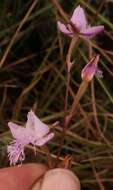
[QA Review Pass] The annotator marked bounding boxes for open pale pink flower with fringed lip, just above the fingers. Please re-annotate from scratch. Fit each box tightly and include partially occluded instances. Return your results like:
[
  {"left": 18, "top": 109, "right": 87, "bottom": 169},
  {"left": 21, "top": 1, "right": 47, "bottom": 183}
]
[{"left": 7, "top": 110, "right": 54, "bottom": 165}]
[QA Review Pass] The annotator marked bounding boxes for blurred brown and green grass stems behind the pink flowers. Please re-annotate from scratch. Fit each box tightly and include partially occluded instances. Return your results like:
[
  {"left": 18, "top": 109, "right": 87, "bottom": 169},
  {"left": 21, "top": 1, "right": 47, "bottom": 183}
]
[{"left": 0, "top": 0, "right": 113, "bottom": 190}]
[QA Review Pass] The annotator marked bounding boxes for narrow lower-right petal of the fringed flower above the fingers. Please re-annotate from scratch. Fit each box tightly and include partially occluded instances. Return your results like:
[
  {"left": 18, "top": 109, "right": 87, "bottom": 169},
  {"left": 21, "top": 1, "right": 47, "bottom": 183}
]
[{"left": 34, "top": 133, "right": 54, "bottom": 146}]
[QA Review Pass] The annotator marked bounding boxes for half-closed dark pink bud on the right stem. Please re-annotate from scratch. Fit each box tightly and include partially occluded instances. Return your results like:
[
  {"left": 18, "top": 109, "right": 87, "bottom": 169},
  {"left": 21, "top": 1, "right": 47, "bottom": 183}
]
[{"left": 81, "top": 55, "right": 102, "bottom": 82}]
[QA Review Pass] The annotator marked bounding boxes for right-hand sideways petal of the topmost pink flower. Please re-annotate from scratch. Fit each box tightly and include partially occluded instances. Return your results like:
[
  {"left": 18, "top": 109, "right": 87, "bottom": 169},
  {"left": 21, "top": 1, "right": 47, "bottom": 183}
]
[{"left": 81, "top": 25, "right": 104, "bottom": 38}]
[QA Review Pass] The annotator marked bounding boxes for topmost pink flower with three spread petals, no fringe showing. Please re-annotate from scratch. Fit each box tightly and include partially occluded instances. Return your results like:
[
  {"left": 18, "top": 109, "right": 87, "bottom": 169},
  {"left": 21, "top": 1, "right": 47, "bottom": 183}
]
[{"left": 57, "top": 5, "right": 104, "bottom": 38}]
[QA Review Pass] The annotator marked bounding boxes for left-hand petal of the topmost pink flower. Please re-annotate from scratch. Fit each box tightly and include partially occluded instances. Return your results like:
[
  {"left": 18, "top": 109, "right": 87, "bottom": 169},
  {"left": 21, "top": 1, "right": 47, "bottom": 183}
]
[{"left": 57, "top": 21, "right": 73, "bottom": 37}]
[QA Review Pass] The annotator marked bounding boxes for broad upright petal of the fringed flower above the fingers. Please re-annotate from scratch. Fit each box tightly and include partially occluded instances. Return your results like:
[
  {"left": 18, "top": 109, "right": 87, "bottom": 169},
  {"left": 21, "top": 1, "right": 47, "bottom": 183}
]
[{"left": 26, "top": 110, "right": 49, "bottom": 138}]
